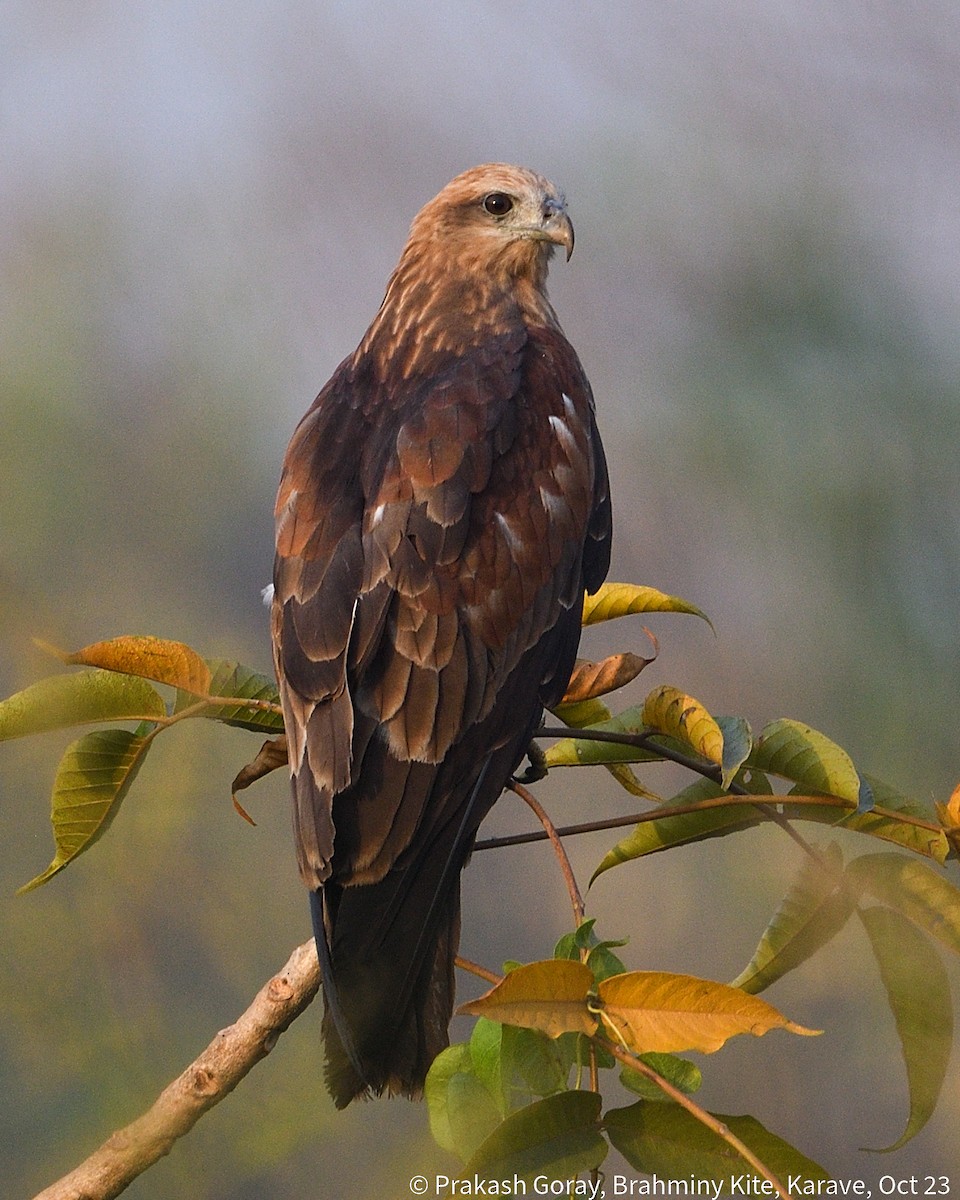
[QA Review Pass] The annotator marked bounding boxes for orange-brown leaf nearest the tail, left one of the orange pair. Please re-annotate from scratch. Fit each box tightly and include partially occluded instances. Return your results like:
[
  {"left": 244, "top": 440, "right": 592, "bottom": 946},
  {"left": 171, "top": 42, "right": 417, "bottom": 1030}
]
[{"left": 457, "top": 959, "right": 596, "bottom": 1038}]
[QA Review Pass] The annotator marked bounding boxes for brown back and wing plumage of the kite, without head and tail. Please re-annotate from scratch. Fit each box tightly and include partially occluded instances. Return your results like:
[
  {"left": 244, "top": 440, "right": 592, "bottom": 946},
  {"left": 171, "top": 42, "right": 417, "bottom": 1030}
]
[{"left": 275, "top": 319, "right": 608, "bottom": 886}]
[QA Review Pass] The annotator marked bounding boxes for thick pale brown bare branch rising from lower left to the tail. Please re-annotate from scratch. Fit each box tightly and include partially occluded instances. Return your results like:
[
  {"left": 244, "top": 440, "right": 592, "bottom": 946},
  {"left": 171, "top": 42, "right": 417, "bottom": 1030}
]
[{"left": 35, "top": 938, "right": 320, "bottom": 1200}]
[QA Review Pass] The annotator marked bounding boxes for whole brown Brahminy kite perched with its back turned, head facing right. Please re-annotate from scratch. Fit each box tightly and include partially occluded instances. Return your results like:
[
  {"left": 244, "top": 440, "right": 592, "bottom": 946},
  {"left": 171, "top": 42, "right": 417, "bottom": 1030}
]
[{"left": 271, "top": 163, "right": 610, "bottom": 1108}]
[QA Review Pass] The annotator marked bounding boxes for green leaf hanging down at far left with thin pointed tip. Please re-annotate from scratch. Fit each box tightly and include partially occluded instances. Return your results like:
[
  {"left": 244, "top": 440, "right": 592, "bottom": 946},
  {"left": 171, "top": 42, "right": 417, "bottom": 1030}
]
[{"left": 19, "top": 730, "right": 150, "bottom": 893}]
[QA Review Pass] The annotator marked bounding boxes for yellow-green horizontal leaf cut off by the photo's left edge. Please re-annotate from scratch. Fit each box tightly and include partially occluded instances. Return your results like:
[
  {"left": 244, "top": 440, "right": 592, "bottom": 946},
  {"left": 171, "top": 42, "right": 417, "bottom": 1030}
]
[{"left": 0, "top": 671, "right": 167, "bottom": 742}]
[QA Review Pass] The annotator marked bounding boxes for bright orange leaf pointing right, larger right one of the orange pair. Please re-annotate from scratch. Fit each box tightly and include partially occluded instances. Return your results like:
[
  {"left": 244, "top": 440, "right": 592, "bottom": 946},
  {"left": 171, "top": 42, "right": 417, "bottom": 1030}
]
[{"left": 598, "top": 971, "right": 817, "bottom": 1054}]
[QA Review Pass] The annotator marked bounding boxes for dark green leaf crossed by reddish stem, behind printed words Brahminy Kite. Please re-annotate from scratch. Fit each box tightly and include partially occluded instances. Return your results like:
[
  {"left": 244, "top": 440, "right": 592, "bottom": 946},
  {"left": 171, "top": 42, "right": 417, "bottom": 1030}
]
[{"left": 604, "top": 1100, "right": 829, "bottom": 1195}]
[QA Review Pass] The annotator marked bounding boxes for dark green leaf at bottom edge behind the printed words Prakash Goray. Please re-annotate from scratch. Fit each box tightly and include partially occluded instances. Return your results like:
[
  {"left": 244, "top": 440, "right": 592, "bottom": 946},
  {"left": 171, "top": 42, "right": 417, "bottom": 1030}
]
[{"left": 450, "top": 1092, "right": 607, "bottom": 1194}]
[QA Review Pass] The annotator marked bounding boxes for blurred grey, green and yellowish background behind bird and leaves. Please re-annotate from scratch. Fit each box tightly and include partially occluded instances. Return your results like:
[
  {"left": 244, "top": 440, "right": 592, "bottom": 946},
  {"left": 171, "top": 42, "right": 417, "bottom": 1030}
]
[{"left": 0, "top": 0, "right": 960, "bottom": 1200}]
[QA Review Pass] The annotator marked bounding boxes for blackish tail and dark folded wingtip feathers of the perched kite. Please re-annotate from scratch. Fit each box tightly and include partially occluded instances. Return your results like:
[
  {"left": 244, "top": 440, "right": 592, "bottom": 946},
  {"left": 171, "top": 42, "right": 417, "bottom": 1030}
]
[{"left": 313, "top": 700, "right": 540, "bottom": 1108}]
